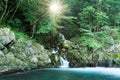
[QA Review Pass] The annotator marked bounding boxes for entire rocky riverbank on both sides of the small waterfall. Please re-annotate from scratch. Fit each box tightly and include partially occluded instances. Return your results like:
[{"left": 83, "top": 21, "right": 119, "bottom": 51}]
[{"left": 0, "top": 28, "right": 120, "bottom": 74}]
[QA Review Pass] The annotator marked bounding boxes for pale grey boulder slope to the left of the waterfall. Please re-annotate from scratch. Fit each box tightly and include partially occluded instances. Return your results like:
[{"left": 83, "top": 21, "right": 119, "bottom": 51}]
[{"left": 0, "top": 28, "right": 51, "bottom": 71}]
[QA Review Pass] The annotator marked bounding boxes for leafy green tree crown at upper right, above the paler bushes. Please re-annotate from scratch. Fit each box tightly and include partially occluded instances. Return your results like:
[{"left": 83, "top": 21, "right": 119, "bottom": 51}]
[{"left": 78, "top": 6, "right": 109, "bottom": 30}]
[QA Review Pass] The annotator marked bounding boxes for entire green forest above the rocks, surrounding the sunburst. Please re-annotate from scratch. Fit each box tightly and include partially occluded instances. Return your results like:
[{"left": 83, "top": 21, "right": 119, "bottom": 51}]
[{"left": 0, "top": 0, "right": 120, "bottom": 67}]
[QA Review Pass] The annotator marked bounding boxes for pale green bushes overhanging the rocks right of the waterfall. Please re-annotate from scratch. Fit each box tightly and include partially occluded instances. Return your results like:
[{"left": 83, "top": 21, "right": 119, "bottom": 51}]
[{"left": 72, "top": 26, "right": 120, "bottom": 50}]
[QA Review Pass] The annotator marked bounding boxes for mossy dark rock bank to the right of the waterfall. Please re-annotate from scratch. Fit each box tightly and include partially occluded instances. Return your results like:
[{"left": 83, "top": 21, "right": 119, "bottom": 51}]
[{"left": 67, "top": 38, "right": 120, "bottom": 67}]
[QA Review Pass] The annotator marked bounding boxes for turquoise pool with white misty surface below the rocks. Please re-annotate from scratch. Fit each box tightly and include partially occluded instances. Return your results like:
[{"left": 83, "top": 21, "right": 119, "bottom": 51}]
[{"left": 0, "top": 68, "right": 120, "bottom": 80}]
